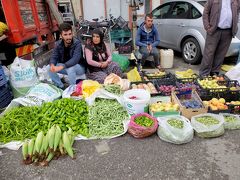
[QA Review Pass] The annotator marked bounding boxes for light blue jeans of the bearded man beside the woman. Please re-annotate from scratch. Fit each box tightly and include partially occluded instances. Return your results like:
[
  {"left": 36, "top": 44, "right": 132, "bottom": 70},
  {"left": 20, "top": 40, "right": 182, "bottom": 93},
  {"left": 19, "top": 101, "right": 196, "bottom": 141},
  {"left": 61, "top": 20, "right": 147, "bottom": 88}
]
[{"left": 48, "top": 63, "right": 85, "bottom": 88}]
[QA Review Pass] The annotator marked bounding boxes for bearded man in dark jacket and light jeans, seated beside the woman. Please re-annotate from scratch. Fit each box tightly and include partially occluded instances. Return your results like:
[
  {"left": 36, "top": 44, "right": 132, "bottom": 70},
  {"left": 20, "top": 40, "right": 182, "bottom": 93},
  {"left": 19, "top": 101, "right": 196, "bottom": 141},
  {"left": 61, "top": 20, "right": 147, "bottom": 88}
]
[{"left": 48, "top": 23, "right": 85, "bottom": 88}]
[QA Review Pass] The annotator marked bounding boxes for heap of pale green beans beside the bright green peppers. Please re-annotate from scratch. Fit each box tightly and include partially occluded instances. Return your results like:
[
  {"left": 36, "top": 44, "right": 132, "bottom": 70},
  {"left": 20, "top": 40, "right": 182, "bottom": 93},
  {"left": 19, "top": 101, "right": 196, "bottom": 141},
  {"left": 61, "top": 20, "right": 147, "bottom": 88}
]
[{"left": 89, "top": 99, "right": 128, "bottom": 138}]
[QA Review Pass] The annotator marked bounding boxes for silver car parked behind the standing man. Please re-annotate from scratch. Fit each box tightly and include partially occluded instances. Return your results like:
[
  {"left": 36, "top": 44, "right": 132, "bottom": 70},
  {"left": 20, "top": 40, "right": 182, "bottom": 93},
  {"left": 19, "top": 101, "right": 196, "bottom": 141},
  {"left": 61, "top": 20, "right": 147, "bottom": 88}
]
[{"left": 145, "top": 0, "right": 240, "bottom": 64}]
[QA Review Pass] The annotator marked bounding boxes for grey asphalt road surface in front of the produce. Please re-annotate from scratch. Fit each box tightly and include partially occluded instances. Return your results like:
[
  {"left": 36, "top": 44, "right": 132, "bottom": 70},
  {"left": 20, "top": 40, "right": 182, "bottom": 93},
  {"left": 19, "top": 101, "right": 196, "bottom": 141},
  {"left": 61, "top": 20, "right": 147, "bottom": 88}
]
[{"left": 0, "top": 54, "right": 240, "bottom": 180}]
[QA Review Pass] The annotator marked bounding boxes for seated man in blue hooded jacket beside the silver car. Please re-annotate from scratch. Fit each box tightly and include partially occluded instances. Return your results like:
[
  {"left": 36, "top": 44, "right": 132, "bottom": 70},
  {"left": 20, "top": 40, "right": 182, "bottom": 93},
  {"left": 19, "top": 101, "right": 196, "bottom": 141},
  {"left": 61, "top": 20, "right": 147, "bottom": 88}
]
[{"left": 136, "top": 14, "right": 164, "bottom": 71}]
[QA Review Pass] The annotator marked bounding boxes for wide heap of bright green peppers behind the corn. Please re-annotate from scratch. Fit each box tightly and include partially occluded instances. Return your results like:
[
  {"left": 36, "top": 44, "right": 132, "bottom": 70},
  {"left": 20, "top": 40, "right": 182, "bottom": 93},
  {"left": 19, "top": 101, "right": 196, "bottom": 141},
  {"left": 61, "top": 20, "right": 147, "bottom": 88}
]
[{"left": 0, "top": 98, "right": 89, "bottom": 143}]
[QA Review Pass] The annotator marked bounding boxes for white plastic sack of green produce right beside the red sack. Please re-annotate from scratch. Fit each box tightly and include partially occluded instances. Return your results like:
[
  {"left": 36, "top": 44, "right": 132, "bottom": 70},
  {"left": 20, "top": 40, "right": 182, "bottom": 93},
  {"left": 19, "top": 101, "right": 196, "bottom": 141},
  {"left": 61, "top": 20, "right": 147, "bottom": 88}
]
[{"left": 157, "top": 116, "right": 193, "bottom": 144}]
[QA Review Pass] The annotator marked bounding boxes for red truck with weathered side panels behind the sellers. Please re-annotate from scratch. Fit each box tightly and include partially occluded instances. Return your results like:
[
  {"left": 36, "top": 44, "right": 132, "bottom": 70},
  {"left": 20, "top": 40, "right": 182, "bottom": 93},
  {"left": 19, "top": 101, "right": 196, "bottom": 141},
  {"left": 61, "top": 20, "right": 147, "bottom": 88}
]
[{"left": 0, "top": 0, "right": 58, "bottom": 66}]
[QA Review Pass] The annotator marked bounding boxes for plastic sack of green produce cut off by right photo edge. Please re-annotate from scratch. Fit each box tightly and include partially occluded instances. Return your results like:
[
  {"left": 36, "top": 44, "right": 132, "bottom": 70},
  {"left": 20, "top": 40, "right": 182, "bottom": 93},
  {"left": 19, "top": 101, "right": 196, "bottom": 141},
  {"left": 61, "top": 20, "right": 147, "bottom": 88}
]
[{"left": 219, "top": 113, "right": 240, "bottom": 130}]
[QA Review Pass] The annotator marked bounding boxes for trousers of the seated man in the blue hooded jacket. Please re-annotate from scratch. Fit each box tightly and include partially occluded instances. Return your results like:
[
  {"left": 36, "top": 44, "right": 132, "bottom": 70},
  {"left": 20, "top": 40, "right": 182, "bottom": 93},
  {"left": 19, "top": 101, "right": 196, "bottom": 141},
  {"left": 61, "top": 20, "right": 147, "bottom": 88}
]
[{"left": 139, "top": 47, "right": 160, "bottom": 67}]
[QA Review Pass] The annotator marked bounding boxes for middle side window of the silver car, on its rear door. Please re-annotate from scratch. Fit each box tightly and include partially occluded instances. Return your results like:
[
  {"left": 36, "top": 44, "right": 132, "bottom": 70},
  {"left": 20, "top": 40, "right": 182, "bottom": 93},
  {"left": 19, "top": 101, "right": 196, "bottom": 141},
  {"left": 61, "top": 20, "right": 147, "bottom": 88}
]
[{"left": 169, "top": 2, "right": 189, "bottom": 19}]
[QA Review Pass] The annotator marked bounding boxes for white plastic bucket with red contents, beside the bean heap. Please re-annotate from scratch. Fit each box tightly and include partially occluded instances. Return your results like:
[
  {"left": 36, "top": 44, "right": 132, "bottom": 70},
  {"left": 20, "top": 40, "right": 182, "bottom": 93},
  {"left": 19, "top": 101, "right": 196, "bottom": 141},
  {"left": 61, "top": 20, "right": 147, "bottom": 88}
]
[{"left": 123, "top": 89, "right": 151, "bottom": 115}]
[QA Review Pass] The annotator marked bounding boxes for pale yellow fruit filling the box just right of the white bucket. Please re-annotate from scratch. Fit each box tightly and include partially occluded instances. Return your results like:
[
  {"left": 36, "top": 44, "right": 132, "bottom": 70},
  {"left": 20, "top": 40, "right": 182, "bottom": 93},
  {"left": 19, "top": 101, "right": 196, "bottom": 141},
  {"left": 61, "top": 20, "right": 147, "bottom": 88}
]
[{"left": 150, "top": 102, "right": 179, "bottom": 112}]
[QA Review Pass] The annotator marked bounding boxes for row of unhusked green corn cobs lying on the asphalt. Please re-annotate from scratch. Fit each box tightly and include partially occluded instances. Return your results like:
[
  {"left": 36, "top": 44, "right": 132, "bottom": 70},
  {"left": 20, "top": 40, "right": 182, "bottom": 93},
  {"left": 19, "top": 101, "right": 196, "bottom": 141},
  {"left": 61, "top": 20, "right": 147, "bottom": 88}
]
[{"left": 22, "top": 125, "right": 74, "bottom": 166}]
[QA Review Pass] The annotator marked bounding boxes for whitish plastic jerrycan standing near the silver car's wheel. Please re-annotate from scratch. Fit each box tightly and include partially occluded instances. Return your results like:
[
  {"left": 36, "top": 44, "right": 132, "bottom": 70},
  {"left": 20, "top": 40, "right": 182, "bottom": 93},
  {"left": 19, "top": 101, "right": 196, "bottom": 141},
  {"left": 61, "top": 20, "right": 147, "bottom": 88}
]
[{"left": 160, "top": 49, "right": 174, "bottom": 68}]
